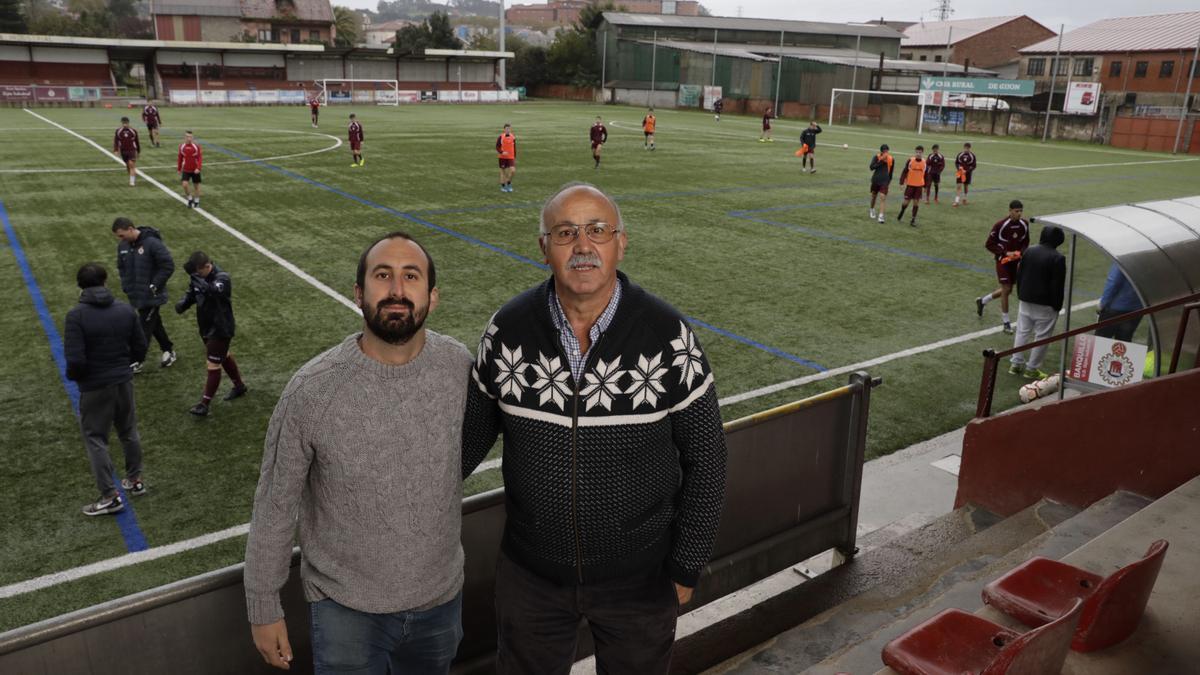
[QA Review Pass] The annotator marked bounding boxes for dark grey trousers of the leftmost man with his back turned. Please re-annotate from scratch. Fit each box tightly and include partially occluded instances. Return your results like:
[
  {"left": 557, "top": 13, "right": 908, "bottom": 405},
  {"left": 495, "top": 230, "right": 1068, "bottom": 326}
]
[{"left": 79, "top": 380, "right": 142, "bottom": 497}]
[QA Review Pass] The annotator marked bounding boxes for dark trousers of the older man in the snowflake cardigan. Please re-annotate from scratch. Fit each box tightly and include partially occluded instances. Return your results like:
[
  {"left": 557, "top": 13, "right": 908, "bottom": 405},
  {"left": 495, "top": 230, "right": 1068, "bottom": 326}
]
[{"left": 496, "top": 554, "right": 679, "bottom": 675}]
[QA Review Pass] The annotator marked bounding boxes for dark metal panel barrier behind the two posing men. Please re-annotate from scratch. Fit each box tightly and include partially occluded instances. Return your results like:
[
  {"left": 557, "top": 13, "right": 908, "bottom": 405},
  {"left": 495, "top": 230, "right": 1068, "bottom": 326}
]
[{"left": 0, "top": 372, "right": 881, "bottom": 675}]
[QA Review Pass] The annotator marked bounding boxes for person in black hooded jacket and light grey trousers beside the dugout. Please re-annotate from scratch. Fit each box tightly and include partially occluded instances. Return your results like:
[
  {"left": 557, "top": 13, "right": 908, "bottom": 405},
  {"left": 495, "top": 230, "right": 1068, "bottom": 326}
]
[{"left": 1008, "top": 225, "right": 1067, "bottom": 380}]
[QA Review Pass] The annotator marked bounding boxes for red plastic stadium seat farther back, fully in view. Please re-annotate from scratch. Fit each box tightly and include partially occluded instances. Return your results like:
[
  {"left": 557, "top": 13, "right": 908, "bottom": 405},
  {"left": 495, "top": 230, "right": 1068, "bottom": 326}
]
[{"left": 983, "top": 539, "right": 1168, "bottom": 652}]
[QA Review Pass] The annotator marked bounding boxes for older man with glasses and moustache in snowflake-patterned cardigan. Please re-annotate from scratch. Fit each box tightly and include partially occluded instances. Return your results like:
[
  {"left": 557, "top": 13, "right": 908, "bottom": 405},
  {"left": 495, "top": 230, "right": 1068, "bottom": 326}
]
[{"left": 463, "top": 184, "right": 726, "bottom": 675}]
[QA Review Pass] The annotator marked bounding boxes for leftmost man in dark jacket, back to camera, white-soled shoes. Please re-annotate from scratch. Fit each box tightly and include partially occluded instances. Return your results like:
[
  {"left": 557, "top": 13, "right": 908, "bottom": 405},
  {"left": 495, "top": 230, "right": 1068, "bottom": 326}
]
[{"left": 64, "top": 263, "right": 146, "bottom": 515}]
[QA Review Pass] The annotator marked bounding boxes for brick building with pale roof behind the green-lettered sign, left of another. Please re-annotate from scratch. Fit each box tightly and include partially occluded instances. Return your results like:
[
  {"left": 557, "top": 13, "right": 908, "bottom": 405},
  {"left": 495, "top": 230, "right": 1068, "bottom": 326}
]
[{"left": 900, "top": 16, "right": 1056, "bottom": 79}]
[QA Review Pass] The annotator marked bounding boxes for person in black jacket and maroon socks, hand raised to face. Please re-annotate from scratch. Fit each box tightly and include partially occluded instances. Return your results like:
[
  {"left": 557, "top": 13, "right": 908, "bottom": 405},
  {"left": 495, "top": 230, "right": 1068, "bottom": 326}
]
[{"left": 175, "top": 251, "right": 246, "bottom": 417}]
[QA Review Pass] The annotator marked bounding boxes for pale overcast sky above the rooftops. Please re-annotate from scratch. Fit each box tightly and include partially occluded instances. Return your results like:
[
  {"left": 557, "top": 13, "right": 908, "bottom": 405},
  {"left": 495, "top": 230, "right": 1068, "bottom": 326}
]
[{"left": 334, "top": 0, "right": 1200, "bottom": 30}]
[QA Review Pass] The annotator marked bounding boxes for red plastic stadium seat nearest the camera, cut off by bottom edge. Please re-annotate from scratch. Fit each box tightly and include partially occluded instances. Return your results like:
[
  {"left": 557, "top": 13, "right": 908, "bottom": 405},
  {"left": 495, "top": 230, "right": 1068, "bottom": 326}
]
[{"left": 883, "top": 601, "right": 1084, "bottom": 675}]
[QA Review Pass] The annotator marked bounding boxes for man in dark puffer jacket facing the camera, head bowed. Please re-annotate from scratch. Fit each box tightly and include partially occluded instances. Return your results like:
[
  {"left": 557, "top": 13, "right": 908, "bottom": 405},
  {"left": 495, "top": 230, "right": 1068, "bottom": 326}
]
[{"left": 113, "top": 217, "right": 175, "bottom": 372}]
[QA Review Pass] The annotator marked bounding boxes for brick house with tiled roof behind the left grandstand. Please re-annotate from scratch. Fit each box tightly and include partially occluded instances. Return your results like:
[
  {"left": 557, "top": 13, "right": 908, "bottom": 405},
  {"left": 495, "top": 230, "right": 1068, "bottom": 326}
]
[{"left": 150, "top": 0, "right": 336, "bottom": 44}]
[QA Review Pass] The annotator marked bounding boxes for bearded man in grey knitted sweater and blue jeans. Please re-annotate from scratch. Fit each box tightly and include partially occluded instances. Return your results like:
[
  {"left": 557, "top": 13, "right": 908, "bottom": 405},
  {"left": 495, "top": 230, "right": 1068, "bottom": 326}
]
[{"left": 245, "top": 232, "right": 473, "bottom": 674}]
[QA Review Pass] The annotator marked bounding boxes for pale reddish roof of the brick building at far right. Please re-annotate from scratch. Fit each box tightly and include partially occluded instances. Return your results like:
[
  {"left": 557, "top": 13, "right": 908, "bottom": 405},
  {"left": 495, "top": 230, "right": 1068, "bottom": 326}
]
[{"left": 1021, "top": 12, "right": 1200, "bottom": 54}]
